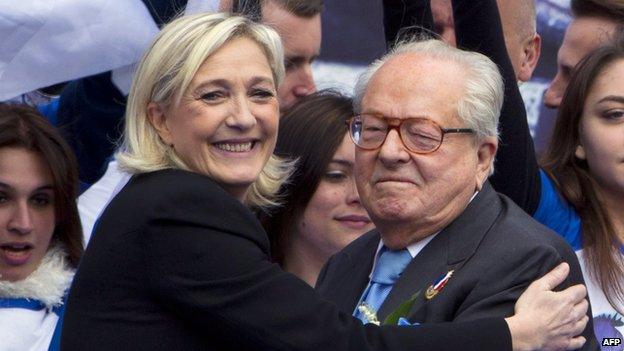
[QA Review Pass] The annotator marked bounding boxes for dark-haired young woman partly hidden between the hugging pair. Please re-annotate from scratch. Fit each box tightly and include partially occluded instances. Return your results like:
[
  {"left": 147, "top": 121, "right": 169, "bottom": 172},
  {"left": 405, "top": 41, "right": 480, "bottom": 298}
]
[{"left": 264, "top": 90, "right": 374, "bottom": 286}]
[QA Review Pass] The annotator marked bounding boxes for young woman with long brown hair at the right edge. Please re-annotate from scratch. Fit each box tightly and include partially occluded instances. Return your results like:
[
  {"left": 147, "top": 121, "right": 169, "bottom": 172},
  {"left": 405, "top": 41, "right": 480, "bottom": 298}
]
[{"left": 534, "top": 39, "right": 624, "bottom": 341}]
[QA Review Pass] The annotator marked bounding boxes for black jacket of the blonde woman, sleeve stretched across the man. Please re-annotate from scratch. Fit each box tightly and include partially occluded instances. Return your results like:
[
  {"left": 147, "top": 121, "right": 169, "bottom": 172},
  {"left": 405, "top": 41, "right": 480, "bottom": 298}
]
[{"left": 61, "top": 170, "right": 511, "bottom": 351}]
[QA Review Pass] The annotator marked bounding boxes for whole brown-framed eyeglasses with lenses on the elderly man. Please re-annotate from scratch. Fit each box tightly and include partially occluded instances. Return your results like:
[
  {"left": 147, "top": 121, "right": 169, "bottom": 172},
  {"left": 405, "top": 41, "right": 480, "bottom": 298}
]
[{"left": 347, "top": 114, "right": 474, "bottom": 154}]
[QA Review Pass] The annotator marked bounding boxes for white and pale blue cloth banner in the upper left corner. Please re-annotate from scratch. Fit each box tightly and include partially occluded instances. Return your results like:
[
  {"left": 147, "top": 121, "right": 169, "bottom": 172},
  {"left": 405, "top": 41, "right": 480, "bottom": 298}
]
[{"left": 0, "top": 0, "right": 158, "bottom": 101}]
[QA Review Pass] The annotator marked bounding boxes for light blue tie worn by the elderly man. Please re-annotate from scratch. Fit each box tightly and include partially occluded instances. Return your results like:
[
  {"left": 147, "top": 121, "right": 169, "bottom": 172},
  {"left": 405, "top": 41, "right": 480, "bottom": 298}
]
[{"left": 353, "top": 246, "right": 412, "bottom": 323}]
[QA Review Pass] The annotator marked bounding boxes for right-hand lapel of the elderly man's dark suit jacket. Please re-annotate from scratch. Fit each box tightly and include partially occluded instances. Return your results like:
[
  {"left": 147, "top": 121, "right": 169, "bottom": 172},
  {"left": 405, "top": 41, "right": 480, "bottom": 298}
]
[{"left": 377, "top": 182, "right": 501, "bottom": 321}]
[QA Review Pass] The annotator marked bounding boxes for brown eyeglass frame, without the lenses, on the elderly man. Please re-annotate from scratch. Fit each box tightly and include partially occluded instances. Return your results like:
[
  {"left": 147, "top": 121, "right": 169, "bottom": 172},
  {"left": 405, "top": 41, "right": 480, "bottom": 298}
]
[{"left": 346, "top": 113, "right": 475, "bottom": 155}]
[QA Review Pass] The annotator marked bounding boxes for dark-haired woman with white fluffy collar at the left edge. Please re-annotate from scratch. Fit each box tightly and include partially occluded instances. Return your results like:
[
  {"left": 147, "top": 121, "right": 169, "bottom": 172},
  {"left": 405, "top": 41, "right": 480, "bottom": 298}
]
[{"left": 0, "top": 105, "right": 83, "bottom": 350}]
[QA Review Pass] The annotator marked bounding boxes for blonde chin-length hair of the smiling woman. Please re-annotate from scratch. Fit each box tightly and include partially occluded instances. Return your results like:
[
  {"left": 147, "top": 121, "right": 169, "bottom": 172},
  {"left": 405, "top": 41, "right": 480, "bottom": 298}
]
[{"left": 115, "top": 13, "right": 292, "bottom": 208}]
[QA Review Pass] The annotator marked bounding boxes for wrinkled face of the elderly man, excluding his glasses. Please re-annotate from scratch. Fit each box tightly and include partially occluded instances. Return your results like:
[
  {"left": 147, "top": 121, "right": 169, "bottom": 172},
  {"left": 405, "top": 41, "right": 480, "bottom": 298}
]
[{"left": 355, "top": 54, "right": 496, "bottom": 248}]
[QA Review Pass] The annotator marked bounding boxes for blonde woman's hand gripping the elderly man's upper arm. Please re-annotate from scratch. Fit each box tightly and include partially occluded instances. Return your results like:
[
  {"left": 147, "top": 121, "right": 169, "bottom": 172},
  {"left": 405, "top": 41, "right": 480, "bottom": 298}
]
[{"left": 505, "top": 263, "right": 589, "bottom": 351}]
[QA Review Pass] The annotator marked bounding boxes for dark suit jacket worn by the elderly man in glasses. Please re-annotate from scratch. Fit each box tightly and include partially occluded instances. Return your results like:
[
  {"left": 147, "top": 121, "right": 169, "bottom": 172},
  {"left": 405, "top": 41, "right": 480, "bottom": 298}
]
[{"left": 316, "top": 182, "right": 597, "bottom": 350}]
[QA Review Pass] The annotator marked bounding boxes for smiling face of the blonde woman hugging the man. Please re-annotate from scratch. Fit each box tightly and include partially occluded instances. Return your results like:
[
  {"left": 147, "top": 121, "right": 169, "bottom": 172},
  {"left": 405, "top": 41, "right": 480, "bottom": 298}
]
[{"left": 148, "top": 37, "right": 279, "bottom": 200}]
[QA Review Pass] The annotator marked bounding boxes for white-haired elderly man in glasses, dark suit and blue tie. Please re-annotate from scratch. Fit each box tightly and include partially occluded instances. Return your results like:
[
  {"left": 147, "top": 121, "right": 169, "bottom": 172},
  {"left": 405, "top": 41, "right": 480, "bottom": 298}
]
[{"left": 317, "top": 40, "right": 596, "bottom": 349}]
